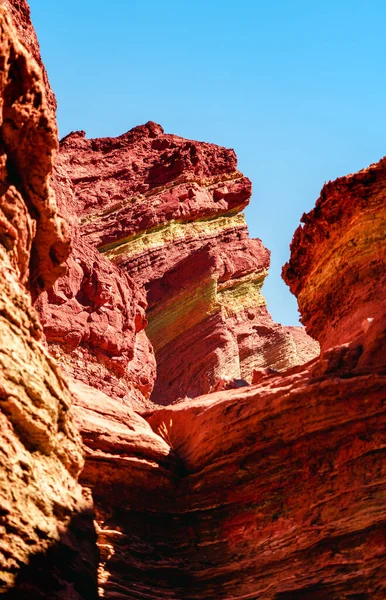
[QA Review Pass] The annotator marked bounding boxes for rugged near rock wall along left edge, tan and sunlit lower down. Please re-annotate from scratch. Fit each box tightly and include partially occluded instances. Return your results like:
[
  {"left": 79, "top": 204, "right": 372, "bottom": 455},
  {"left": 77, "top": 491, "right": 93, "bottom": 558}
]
[{"left": 0, "top": 5, "right": 97, "bottom": 600}]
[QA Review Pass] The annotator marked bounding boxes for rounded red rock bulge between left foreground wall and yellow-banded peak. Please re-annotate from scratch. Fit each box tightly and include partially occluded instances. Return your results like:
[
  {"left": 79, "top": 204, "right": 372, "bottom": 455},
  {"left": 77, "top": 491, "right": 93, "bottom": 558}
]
[{"left": 38, "top": 156, "right": 155, "bottom": 408}]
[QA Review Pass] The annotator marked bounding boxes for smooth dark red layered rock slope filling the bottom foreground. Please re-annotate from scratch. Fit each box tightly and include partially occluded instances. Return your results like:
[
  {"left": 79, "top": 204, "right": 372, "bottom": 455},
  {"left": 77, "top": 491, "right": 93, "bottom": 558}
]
[{"left": 73, "top": 158, "right": 386, "bottom": 600}]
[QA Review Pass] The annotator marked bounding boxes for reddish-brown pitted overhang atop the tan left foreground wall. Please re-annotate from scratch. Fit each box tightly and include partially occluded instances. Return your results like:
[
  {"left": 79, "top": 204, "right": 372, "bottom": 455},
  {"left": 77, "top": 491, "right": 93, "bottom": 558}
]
[{"left": 1, "top": 1, "right": 69, "bottom": 296}]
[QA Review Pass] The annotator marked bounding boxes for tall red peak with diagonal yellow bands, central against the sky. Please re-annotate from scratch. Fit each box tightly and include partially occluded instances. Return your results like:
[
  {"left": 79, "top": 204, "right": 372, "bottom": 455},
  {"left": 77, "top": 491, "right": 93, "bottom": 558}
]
[{"left": 49, "top": 122, "right": 318, "bottom": 406}]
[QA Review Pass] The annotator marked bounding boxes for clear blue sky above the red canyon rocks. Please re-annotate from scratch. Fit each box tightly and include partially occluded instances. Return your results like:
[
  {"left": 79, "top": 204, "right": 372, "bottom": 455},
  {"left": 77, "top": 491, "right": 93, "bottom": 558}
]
[{"left": 30, "top": 0, "right": 386, "bottom": 324}]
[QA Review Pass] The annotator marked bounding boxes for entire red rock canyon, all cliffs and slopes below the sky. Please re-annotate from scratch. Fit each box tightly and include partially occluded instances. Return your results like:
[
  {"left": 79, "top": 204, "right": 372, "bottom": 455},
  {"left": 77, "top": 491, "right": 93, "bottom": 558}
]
[{"left": 0, "top": 0, "right": 386, "bottom": 600}]
